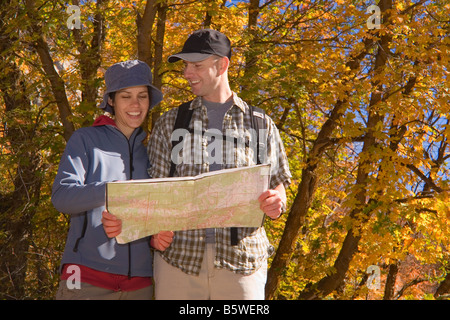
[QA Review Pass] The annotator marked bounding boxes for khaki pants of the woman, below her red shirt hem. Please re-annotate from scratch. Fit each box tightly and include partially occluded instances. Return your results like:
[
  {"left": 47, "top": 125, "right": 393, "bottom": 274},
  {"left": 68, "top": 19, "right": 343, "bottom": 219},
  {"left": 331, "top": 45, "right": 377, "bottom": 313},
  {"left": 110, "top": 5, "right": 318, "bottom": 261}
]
[{"left": 56, "top": 280, "right": 153, "bottom": 300}]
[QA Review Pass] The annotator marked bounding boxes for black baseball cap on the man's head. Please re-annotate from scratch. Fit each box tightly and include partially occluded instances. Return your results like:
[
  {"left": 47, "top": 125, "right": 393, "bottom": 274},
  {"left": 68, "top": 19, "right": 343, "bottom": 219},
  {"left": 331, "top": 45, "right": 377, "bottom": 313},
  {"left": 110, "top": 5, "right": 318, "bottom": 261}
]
[{"left": 168, "top": 29, "right": 231, "bottom": 62}]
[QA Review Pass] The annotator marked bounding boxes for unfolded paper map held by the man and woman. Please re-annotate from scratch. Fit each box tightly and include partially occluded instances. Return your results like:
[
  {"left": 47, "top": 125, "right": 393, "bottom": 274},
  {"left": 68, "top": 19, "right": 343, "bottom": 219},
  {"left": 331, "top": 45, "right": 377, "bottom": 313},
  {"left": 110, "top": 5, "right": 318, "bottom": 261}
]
[{"left": 106, "top": 165, "right": 270, "bottom": 243}]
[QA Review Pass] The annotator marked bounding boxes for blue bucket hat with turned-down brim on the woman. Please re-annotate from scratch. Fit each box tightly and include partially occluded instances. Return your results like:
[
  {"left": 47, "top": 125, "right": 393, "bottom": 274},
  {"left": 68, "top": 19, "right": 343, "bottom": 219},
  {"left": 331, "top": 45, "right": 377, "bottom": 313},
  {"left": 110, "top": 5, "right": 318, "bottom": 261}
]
[{"left": 98, "top": 60, "right": 163, "bottom": 113}]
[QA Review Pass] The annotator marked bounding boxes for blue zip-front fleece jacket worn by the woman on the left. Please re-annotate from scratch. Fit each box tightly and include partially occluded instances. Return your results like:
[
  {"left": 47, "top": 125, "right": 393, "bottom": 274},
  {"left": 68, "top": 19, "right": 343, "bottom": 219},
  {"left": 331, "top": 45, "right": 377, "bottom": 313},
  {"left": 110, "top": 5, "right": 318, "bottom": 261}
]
[{"left": 52, "top": 116, "right": 152, "bottom": 277}]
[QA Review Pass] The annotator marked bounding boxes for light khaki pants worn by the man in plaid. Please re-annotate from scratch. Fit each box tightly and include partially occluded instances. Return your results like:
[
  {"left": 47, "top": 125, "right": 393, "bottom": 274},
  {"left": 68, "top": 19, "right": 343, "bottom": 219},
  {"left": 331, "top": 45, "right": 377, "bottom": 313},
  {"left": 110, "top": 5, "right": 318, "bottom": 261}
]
[{"left": 153, "top": 244, "right": 267, "bottom": 300}]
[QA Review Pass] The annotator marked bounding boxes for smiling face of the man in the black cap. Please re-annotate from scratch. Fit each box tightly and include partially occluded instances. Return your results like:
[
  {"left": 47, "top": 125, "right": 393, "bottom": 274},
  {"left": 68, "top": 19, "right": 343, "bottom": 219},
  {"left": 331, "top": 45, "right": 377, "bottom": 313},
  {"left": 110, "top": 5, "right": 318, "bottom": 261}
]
[{"left": 184, "top": 56, "right": 222, "bottom": 101}]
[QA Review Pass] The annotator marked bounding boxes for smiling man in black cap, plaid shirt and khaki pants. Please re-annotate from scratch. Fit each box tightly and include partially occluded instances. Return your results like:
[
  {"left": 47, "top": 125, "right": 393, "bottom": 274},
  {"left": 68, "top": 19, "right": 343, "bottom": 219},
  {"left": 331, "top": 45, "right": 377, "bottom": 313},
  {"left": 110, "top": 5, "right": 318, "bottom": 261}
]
[{"left": 148, "top": 29, "right": 291, "bottom": 299}]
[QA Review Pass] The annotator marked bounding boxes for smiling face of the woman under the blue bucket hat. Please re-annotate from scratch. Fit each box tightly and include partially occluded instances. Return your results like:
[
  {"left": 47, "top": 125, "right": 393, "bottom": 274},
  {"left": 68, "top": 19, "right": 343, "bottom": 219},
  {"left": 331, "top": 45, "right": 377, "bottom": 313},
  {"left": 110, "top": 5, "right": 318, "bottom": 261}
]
[{"left": 108, "top": 86, "right": 150, "bottom": 138}]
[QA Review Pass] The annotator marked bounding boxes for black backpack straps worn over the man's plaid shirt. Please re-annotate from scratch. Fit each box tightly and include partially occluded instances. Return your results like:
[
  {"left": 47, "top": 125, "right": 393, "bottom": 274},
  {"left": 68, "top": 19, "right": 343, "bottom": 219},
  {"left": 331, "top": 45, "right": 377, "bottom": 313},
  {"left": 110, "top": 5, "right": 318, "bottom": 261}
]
[{"left": 169, "top": 101, "right": 266, "bottom": 246}]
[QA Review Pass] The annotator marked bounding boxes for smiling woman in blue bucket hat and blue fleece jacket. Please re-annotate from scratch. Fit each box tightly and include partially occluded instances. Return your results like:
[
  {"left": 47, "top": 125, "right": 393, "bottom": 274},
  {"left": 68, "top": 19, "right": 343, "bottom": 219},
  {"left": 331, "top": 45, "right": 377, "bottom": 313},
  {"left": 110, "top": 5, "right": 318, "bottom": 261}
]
[{"left": 52, "top": 60, "right": 171, "bottom": 299}]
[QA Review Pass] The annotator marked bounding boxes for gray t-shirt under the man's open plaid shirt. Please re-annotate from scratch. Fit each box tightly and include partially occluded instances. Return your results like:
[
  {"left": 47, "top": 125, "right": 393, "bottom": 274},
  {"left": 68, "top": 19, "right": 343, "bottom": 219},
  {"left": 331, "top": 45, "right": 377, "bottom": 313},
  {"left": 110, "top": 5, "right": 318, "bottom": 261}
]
[{"left": 203, "top": 99, "right": 233, "bottom": 243}]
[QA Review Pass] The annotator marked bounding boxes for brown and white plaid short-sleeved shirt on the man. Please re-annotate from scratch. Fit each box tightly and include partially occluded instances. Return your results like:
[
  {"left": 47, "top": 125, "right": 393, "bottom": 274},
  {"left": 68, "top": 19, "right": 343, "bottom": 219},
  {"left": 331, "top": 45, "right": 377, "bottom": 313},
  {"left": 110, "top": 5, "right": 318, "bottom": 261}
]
[{"left": 148, "top": 93, "right": 291, "bottom": 275}]
